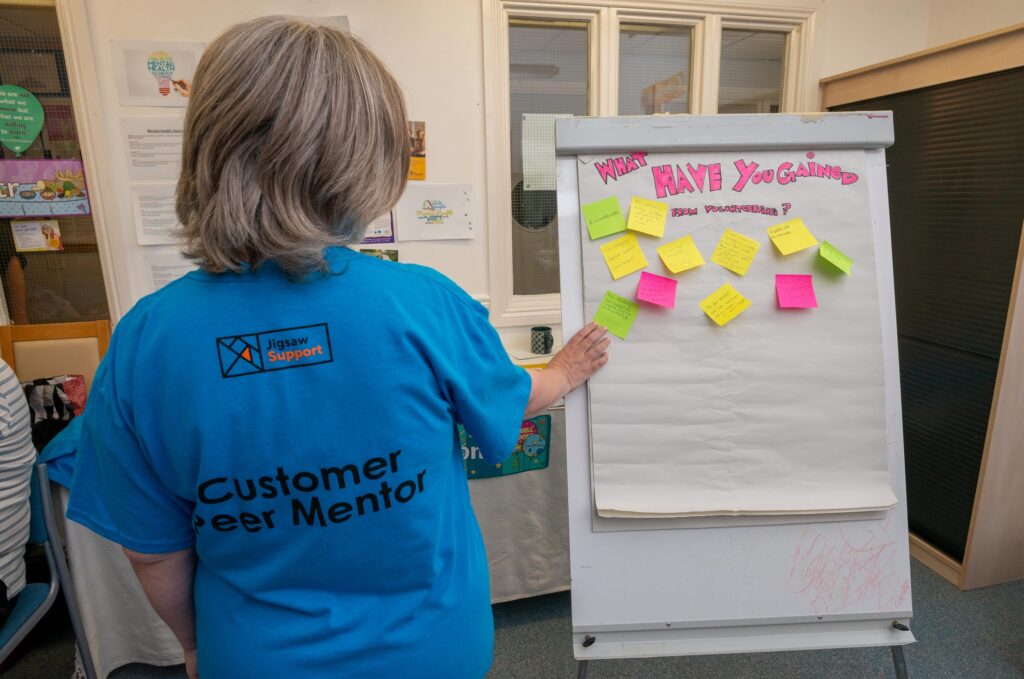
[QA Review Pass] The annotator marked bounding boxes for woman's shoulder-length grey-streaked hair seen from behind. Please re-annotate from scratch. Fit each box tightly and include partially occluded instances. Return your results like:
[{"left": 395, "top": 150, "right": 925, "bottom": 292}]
[{"left": 175, "top": 16, "right": 409, "bottom": 278}]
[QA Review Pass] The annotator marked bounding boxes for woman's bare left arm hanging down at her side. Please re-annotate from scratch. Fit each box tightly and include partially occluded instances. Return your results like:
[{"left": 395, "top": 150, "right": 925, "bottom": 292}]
[{"left": 124, "top": 548, "right": 199, "bottom": 679}]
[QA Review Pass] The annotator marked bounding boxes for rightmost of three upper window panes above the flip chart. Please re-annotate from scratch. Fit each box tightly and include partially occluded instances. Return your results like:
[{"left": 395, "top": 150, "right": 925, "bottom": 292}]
[{"left": 718, "top": 29, "right": 786, "bottom": 113}]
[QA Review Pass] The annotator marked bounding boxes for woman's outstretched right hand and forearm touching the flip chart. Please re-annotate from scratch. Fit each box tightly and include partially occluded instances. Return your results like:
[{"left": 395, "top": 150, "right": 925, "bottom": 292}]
[{"left": 524, "top": 323, "right": 611, "bottom": 418}]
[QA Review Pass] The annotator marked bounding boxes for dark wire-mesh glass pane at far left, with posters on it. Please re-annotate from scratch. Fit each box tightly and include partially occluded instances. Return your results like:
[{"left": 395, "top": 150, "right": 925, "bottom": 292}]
[{"left": 0, "top": 5, "right": 110, "bottom": 324}]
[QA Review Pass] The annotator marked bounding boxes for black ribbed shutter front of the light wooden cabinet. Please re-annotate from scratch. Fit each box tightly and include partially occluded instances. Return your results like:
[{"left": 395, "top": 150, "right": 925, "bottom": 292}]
[{"left": 833, "top": 69, "right": 1024, "bottom": 560}]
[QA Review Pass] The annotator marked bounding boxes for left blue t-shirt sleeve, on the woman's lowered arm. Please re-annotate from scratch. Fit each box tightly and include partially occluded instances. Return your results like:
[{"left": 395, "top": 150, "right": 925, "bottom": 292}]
[{"left": 68, "top": 333, "right": 196, "bottom": 554}]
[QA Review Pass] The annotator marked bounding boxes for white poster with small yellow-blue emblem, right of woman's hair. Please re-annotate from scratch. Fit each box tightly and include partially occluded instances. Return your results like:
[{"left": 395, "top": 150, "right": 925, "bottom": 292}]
[{"left": 395, "top": 184, "right": 473, "bottom": 241}]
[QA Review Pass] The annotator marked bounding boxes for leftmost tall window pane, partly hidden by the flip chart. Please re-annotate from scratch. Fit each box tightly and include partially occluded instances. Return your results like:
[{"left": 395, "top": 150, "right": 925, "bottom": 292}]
[{"left": 509, "top": 19, "right": 589, "bottom": 295}]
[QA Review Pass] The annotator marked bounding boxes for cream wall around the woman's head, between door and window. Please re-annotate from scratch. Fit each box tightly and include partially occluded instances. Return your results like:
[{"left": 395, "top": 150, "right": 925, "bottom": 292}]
[{"left": 69, "top": 0, "right": 487, "bottom": 317}]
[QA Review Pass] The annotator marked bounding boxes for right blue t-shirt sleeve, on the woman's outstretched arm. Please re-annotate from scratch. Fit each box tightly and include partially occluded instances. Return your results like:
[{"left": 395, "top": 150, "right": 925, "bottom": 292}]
[{"left": 430, "top": 291, "right": 532, "bottom": 462}]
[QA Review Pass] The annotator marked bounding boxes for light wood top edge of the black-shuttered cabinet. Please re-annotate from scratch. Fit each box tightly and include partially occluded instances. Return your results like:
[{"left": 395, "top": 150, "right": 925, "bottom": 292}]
[{"left": 821, "top": 24, "right": 1024, "bottom": 110}]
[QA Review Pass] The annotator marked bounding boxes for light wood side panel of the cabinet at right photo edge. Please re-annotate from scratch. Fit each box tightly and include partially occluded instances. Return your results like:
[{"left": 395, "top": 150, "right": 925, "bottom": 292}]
[{"left": 962, "top": 227, "right": 1024, "bottom": 589}]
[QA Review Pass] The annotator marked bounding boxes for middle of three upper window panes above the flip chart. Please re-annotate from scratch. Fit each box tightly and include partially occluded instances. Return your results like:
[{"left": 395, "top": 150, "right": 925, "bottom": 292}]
[{"left": 618, "top": 24, "right": 692, "bottom": 116}]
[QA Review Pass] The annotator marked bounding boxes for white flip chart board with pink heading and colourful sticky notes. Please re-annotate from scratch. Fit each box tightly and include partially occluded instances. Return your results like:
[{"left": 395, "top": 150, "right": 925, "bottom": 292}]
[{"left": 556, "top": 113, "right": 912, "bottom": 657}]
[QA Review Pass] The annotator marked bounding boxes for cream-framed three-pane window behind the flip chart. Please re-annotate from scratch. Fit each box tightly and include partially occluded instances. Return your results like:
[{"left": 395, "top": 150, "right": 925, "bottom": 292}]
[{"left": 481, "top": 0, "right": 817, "bottom": 326}]
